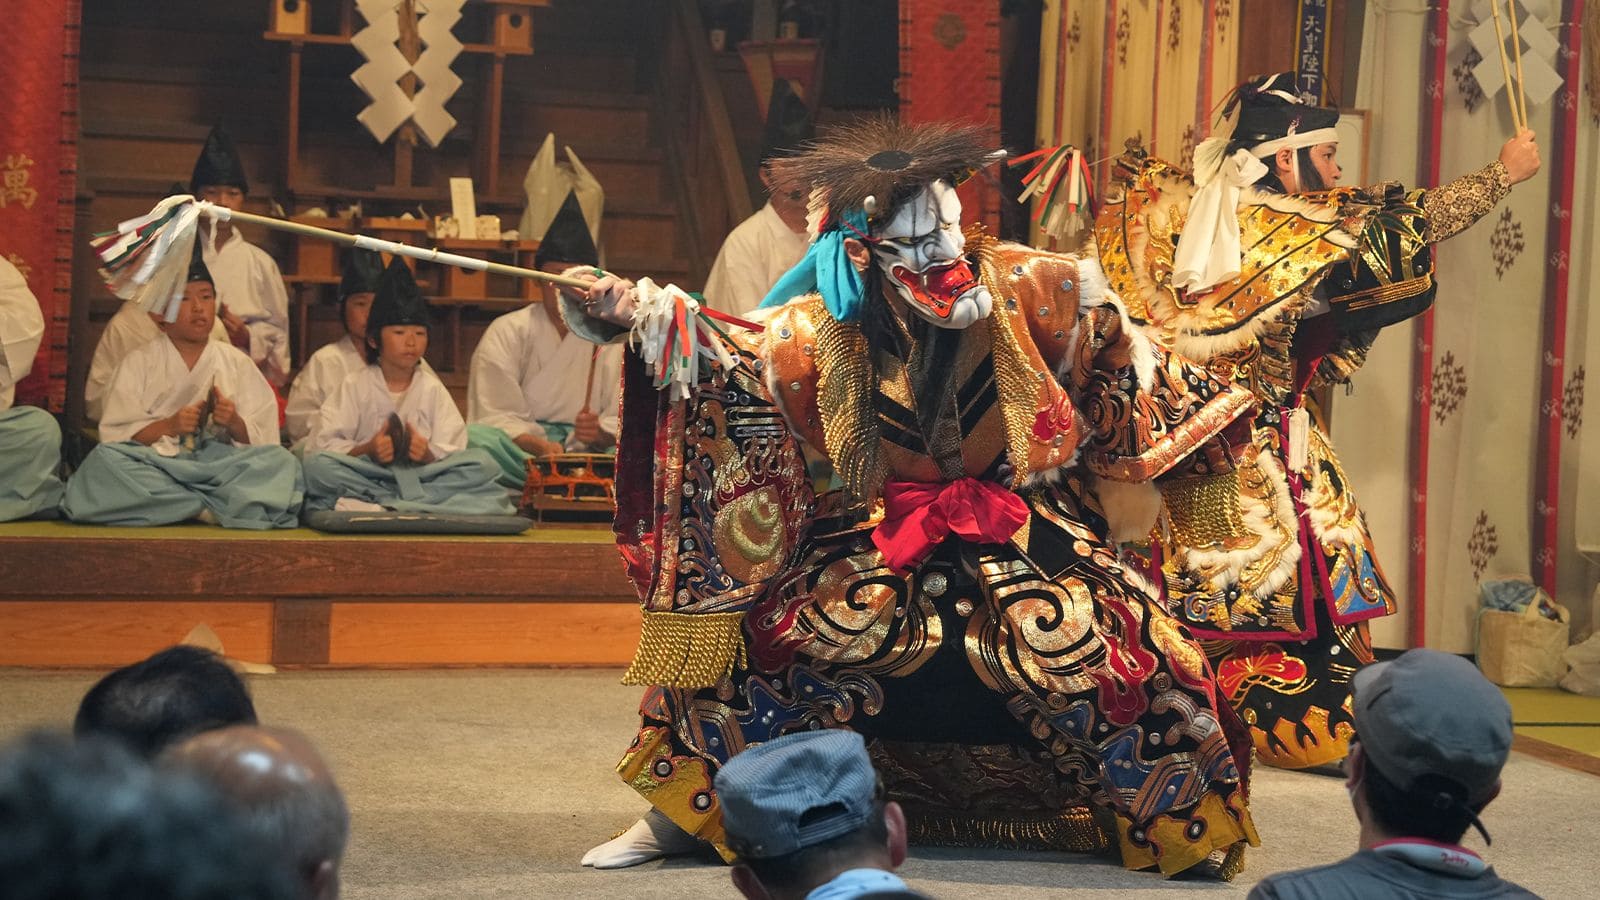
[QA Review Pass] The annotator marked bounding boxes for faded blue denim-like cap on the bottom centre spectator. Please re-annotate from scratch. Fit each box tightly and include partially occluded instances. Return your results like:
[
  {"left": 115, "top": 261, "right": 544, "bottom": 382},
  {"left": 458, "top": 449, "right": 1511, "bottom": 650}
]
[{"left": 715, "top": 729, "right": 877, "bottom": 860}]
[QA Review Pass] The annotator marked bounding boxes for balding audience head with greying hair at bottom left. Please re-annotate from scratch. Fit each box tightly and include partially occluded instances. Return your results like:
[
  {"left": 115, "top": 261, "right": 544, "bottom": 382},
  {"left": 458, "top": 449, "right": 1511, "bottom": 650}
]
[{"left": 162, "top": 725, "right": 350, "bottom": 900}]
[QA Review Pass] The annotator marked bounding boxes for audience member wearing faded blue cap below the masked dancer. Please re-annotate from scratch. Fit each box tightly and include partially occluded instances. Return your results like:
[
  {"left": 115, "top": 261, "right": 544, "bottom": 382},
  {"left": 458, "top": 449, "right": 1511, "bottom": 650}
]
[{"left": 717, "top": 730, "right": 918, "bottom": 900}]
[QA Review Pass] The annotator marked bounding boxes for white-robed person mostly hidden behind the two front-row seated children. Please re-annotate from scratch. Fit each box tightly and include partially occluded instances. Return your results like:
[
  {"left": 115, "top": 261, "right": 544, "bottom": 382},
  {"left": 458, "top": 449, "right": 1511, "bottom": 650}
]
[{"left": 283, "top": 250, "right": 403, "bottom": 450}]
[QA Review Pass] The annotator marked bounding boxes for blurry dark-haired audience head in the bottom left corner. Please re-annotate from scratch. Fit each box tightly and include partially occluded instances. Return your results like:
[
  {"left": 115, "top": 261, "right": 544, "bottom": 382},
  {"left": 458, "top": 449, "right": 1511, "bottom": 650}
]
[{"left": 0, "top": 733, "right": 294, "bottom": 900}]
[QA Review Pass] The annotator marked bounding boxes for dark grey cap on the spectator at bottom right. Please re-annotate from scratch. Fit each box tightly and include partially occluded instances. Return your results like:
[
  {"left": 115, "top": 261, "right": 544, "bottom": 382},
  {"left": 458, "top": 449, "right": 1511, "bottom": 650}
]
[{"left": 1350, "top": 649, "right": 1512, "bottom": 806}]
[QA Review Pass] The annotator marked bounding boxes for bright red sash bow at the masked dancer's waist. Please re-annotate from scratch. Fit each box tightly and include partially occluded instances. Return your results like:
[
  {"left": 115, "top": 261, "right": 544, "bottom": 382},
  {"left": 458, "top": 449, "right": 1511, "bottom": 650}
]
[{"left": 872, "top": 479, "right": 1027, "bottom": 572}]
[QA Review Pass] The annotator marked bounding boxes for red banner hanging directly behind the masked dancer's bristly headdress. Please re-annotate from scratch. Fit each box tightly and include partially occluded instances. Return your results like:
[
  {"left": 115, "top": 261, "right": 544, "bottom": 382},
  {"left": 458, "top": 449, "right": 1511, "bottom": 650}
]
[{"left": 898, "top": 0, "right": 1000, "bottom": 232}]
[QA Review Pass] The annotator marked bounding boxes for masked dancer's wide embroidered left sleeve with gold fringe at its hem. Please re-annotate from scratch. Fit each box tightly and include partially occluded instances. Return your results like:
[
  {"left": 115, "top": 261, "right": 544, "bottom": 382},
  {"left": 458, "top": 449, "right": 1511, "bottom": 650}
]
[{"left": 616, "top": 341, "right": 814, "bottom": 687}]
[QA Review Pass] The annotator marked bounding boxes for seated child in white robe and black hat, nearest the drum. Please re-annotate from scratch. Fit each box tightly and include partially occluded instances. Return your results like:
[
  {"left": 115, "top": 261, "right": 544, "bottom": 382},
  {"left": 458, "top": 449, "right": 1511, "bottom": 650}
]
[{"left": 306, "top": 258, "right": 515, "bottom": 516}]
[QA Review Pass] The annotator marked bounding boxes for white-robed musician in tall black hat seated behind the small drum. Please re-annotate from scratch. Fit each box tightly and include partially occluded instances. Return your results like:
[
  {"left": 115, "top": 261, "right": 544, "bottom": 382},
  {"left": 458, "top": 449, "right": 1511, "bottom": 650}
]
[{"left": 467, "top": 187, "right": 622, "bottom": 490}]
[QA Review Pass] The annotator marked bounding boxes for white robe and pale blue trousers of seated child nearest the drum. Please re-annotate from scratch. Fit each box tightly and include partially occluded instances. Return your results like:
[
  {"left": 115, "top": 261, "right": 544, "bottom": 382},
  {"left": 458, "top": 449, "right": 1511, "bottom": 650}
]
[{"left": 306, "top": 364, "right": 515, "bottom": 516}]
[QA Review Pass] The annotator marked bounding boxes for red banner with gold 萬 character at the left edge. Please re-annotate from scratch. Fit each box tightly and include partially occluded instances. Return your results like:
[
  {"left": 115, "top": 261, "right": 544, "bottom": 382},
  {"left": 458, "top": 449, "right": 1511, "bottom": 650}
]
[{"left": 0, "top": 0, "right": 80, "bottom": 412}]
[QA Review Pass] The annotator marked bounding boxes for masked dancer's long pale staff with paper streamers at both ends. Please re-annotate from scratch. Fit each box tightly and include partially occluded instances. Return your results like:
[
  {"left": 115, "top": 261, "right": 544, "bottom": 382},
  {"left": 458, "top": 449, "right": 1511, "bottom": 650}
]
[{"left": 90, "top": 194, "right": 748, "bottom": 399}]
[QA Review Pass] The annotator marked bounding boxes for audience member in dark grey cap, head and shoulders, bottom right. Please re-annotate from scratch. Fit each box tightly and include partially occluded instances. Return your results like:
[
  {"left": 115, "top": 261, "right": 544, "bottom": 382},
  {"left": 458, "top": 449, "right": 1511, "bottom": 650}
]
[{"left": 1250, "top": 649, "right": 1533, "bottom": 900}]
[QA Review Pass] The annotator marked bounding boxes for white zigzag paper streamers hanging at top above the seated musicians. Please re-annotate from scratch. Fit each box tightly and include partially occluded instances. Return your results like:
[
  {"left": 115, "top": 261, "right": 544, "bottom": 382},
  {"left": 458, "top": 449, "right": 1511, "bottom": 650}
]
[{"left": 350, "top": 0, "right": 466, "bottom": 147}]
